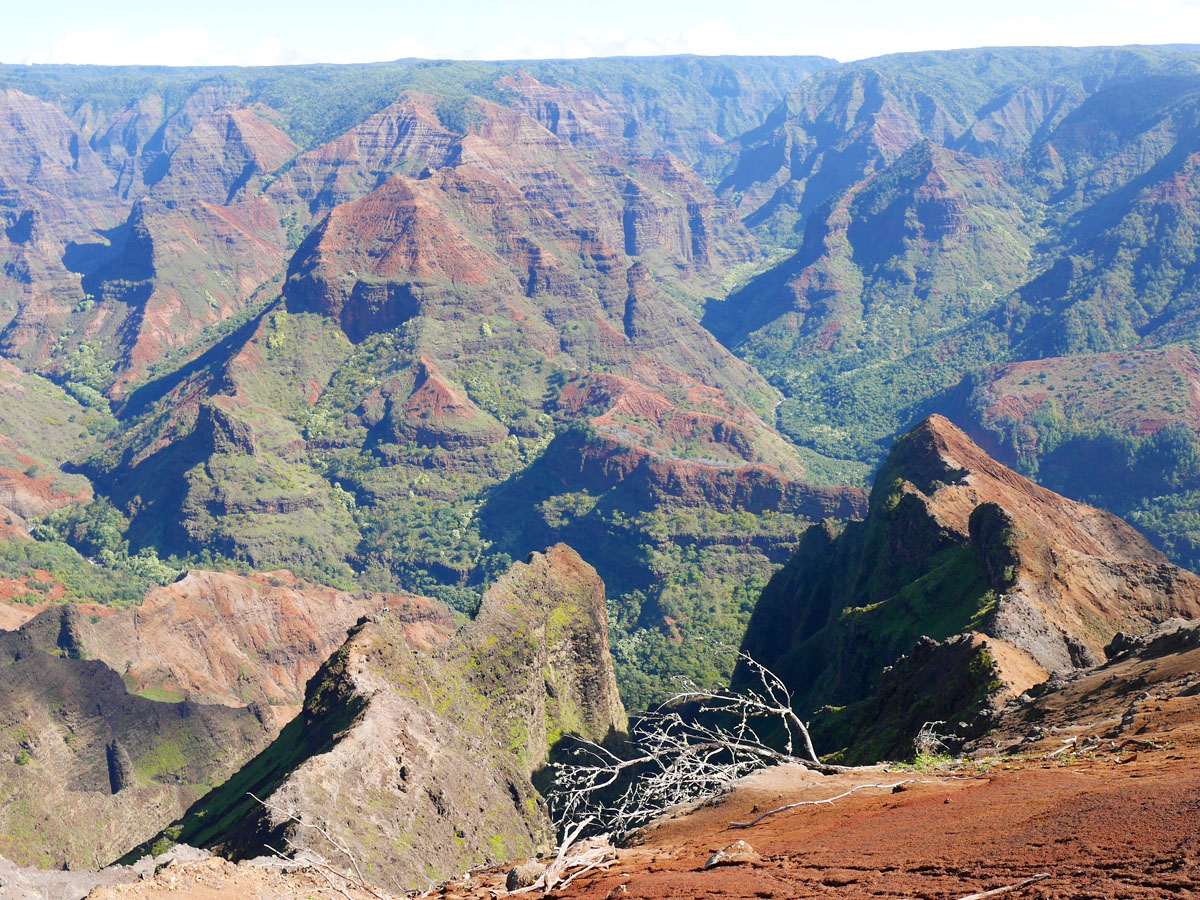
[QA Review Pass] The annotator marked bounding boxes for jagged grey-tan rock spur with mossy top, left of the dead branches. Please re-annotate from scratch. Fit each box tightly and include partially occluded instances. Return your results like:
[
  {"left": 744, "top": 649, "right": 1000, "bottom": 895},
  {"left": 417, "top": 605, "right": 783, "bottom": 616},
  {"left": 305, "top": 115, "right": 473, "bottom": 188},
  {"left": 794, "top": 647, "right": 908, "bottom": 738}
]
[{"left": 154, "top": 546, "right": 625, "bottom": 886}]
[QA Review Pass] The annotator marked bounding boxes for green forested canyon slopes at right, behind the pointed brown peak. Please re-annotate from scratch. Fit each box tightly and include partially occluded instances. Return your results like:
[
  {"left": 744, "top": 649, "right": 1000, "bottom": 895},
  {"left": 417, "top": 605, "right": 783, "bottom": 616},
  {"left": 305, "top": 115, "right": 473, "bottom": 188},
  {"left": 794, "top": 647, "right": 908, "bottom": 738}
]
[{"left": 704, "top": 48, "right": 1200, "bottom": 578}]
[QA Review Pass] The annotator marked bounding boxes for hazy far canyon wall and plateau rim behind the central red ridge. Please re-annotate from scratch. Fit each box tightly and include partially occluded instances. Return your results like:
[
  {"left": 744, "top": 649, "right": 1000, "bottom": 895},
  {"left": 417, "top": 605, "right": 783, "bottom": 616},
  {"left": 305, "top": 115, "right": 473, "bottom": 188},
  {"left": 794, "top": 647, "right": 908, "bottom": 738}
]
[{"left": 0, "top": 58, "right": 828, "bottom": 384}]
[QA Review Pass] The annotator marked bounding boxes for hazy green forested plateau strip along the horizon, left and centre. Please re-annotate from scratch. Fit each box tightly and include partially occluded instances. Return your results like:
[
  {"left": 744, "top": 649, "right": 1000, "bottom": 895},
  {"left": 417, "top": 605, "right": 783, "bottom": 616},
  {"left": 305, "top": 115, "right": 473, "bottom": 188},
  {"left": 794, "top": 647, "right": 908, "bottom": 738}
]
[{"left": 0, "top": 56, "right": 830, "bottom": 159}]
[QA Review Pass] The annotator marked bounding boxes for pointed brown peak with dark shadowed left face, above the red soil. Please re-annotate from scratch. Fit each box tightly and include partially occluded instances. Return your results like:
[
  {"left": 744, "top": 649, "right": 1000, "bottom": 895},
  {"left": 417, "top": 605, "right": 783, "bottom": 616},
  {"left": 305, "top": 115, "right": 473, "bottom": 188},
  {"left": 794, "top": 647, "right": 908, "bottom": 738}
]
[{"left": 744, "top": 416, "right": 1200, "bottom": 756}]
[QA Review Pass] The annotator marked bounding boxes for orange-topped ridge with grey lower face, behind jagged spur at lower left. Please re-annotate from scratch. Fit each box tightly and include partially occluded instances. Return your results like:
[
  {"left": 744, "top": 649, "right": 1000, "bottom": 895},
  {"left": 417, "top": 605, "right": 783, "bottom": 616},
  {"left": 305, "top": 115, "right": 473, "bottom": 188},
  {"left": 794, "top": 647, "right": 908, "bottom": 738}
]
[{"left": 0, "top": 571, "right": 454, "bottom": 868}]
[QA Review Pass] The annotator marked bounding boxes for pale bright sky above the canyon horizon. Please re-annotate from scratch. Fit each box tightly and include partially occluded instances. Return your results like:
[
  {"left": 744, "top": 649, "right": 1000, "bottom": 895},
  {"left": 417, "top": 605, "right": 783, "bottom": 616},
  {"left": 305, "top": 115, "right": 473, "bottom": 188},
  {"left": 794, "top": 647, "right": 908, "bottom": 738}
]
[{"left": 0, "top": 0, "right": 1200, "bottom": 65}]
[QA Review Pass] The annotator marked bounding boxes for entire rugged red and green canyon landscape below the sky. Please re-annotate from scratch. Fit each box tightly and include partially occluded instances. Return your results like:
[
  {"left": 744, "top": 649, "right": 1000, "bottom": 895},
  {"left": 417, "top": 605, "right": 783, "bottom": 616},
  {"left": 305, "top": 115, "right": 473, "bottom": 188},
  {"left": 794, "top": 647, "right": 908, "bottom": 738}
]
[{"left": 0, "top": 46, "right": 1200, "bottom": 896}]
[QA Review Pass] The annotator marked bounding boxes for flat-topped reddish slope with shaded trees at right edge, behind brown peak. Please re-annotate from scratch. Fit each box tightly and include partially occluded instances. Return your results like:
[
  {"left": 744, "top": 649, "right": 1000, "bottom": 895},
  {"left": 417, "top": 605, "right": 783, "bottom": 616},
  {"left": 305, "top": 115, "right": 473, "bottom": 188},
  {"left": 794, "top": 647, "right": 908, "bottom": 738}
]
[{"left": 946, "top": 346, "right": 1200, "bottom": 569}]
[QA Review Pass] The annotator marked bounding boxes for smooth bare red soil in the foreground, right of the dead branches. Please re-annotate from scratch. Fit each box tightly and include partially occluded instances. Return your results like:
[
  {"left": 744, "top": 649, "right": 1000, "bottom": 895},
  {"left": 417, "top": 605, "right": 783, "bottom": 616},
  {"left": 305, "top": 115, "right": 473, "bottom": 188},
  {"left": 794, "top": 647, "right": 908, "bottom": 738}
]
[{"left": 549, "top": 752, "right": 1200, "bottom": 900}]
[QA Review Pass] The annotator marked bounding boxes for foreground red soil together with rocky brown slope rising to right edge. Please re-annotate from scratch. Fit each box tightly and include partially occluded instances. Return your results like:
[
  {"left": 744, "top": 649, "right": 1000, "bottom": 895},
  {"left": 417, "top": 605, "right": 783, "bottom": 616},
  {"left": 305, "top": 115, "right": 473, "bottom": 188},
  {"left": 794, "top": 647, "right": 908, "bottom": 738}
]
[{"left": 440, "top": 629, "right": 1200, "bottom": 900}]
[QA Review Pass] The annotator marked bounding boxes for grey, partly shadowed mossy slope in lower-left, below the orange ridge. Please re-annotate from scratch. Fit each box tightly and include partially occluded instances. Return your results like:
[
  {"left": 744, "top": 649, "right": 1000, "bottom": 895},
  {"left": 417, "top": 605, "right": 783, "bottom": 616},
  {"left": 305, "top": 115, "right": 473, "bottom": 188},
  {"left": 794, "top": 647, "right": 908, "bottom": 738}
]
[{"left": 0, "top": 613, "right": 277, "bottom": 868}]
